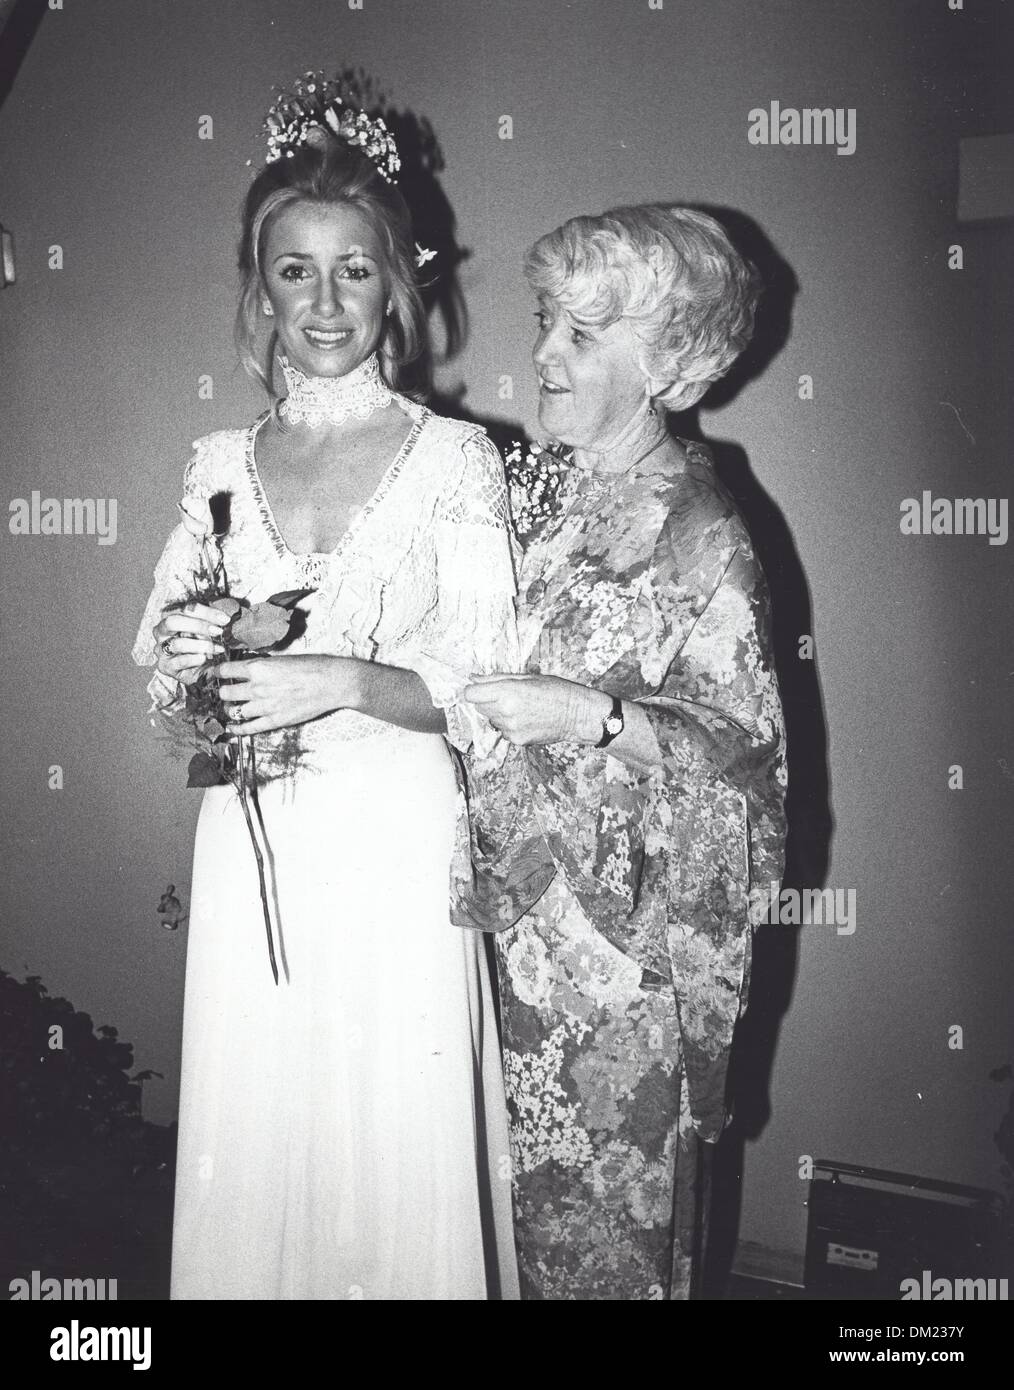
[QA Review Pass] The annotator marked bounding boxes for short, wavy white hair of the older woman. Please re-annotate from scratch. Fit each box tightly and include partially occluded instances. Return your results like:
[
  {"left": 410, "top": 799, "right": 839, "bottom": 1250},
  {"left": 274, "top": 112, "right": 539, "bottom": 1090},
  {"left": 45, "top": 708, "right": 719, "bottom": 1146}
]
[{"left": 524, "top": 203, "right": 761, "bottom": 410}]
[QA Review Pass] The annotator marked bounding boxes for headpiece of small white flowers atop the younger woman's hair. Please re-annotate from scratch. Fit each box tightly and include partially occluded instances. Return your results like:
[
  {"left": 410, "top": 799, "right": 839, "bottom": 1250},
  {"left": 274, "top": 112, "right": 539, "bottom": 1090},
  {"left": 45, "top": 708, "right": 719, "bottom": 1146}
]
[{"left": 264, "top": 68, "right": 402, "bottom": 183}]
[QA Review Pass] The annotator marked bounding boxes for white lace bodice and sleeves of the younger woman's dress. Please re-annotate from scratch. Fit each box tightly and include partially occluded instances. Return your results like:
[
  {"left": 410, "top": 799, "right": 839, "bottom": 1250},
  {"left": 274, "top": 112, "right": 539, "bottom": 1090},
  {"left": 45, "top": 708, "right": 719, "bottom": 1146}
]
[{"left": 134, "top": 395, "right": 519, "bottom": 756}]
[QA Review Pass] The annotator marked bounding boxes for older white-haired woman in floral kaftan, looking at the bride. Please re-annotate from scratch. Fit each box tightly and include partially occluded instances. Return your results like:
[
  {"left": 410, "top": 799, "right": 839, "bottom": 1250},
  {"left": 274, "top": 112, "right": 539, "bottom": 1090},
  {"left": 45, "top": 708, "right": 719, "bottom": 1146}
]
[{"left": 459, "top": 204, "right": 784, "bottom": 1300}]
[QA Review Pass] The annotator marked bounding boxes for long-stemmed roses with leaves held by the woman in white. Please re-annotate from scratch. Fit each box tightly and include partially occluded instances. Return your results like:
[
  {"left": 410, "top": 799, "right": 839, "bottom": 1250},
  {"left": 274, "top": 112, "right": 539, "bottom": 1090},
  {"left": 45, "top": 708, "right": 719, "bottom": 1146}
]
[{"left": 161, "top": 492, "right": 313, "bottom": 984}]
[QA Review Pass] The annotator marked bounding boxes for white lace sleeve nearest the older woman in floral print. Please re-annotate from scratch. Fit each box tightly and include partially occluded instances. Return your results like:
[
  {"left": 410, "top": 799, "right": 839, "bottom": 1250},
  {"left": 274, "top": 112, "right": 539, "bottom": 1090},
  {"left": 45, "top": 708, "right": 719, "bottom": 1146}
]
[{"left": 412, "top": 431, "right": 520, "bottom": 758}]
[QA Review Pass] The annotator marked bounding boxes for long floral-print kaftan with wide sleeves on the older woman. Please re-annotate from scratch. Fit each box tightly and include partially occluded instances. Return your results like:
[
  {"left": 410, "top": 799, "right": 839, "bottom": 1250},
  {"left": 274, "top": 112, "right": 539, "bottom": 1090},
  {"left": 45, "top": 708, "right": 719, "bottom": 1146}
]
[{"left": 456, "top": 443, "right": 786, "bottom": 1300}]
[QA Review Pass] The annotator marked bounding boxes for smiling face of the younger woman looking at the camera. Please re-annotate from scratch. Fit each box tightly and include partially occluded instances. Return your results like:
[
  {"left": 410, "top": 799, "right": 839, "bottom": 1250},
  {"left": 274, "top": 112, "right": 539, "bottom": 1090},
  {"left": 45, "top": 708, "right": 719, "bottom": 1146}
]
[{"left": 263, "top": 202, "right": 388, "bottom": 377}]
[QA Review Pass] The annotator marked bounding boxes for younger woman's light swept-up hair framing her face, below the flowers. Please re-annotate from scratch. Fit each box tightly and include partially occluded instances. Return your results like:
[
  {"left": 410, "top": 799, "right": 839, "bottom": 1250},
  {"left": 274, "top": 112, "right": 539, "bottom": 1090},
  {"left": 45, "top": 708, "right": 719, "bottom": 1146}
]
[{"left": 235, "top": 129, "right": 430, "bottom": 407}]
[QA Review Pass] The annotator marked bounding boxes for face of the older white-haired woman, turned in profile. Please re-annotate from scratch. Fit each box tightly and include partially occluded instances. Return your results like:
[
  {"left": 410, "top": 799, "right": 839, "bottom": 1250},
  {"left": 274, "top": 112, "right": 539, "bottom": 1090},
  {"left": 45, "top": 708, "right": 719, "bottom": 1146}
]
[{"left": 531, "top": 296, "right": 647, "bottom": 450}]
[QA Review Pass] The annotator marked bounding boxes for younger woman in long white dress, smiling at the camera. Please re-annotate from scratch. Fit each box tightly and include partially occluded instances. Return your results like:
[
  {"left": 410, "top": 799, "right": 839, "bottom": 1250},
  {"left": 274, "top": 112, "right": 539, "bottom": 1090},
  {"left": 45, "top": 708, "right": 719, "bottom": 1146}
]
[{"left": 134, "top": 78, "right": 517, "bottom": 1300}]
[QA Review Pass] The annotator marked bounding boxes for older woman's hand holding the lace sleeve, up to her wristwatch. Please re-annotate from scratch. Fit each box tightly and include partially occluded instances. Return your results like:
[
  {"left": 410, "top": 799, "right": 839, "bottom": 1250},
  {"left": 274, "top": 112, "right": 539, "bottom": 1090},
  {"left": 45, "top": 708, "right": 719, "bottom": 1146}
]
[{"left": 465, "top": 676, "right": 612, "bottom": 746}]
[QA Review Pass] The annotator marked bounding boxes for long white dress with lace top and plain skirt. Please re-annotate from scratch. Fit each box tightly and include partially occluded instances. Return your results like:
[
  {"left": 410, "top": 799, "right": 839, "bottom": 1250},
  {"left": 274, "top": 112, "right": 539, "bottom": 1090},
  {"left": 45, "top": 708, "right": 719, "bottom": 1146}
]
[{"left": 134, "top": 396, "right": 517, "bottom": 1300}]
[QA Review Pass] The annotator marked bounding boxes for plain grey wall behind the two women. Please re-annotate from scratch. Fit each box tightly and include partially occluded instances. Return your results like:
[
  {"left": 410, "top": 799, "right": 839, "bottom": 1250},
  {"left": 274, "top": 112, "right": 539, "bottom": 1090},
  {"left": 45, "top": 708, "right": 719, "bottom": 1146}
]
[{"left": 0, "top": 0, "right": 1014, "bottom": 1278}]
